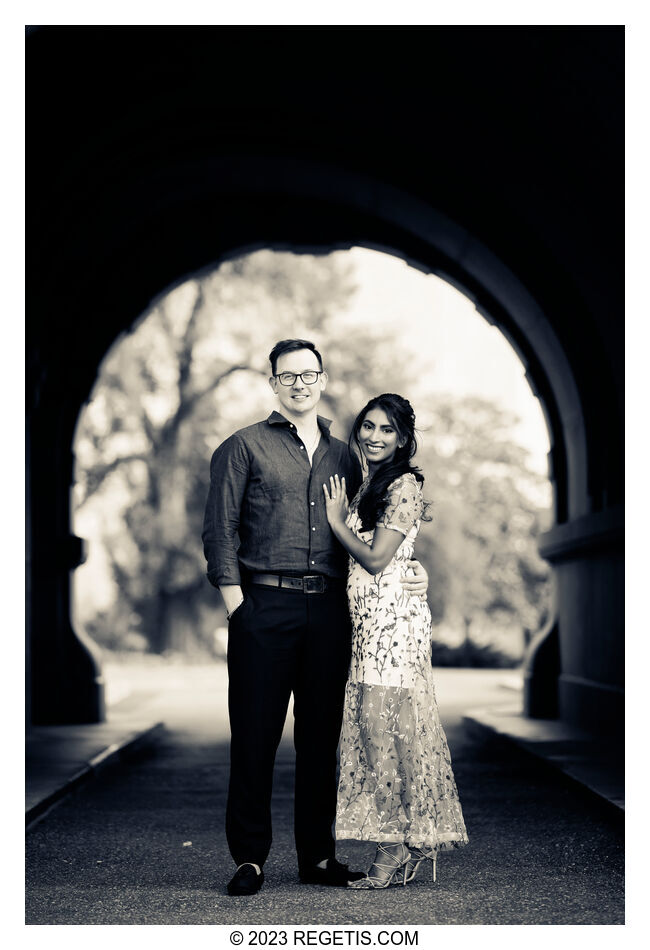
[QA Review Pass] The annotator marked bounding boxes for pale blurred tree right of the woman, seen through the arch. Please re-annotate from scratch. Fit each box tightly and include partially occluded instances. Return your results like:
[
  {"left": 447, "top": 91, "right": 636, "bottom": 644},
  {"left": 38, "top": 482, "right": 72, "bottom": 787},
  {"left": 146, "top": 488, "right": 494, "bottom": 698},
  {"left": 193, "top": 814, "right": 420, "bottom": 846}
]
[{"left": 410, "top": 397, "right": 551, "bottom": 654}]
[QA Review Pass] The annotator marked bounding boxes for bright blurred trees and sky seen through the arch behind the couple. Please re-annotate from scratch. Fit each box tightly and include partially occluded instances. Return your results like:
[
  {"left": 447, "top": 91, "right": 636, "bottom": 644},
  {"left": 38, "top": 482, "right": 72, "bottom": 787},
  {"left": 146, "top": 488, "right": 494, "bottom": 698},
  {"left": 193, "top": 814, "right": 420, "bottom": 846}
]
[{"left": 73, "top": 248, "right": 553, "bottom": 689}]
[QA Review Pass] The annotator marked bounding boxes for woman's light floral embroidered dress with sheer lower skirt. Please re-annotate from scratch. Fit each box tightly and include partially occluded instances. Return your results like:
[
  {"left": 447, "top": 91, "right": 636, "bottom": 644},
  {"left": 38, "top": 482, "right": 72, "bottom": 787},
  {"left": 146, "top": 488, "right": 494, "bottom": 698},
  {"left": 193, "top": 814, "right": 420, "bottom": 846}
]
[{"left": 336, "top": 473, "right": 468, "bottom": 850}]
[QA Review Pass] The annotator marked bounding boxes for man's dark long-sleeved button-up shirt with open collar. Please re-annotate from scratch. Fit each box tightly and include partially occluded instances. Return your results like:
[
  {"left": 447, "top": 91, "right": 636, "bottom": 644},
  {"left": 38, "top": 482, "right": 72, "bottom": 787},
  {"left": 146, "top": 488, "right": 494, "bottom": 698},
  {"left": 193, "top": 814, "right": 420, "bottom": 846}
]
[{"left": 203, "top": 412, "right": 361, "bottom": 587}]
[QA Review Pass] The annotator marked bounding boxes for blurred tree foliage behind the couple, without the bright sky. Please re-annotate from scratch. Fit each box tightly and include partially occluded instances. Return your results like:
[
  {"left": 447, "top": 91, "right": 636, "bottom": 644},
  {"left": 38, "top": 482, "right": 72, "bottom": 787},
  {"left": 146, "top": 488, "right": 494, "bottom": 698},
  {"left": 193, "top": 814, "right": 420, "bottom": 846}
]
[{"left": 75, "top": 251, "right": 549, "bottom": 656}]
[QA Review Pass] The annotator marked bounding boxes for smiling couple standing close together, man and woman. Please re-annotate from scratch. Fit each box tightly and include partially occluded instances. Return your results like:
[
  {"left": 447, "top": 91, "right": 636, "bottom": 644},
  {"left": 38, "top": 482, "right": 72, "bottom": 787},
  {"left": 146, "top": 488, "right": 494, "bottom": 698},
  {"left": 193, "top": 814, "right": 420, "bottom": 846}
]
[{"left": 203, "top": 340, "right": 467, "bottom": 895}]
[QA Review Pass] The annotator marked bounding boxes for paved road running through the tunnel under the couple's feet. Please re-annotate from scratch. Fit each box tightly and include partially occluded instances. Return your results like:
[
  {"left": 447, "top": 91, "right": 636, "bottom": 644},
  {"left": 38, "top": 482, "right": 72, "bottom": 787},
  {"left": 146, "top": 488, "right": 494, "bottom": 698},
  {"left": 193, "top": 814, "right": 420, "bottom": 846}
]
[{"left": 26, "top": 668, "right": 624, "bottom": 926}]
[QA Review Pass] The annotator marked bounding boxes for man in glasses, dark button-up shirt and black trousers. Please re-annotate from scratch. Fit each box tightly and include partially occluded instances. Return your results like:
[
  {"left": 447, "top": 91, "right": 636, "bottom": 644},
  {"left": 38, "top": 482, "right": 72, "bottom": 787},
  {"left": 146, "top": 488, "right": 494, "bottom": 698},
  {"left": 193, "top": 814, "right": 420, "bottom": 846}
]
[{"left": 203, "top": 340, "right": 428, "bottom": 895}]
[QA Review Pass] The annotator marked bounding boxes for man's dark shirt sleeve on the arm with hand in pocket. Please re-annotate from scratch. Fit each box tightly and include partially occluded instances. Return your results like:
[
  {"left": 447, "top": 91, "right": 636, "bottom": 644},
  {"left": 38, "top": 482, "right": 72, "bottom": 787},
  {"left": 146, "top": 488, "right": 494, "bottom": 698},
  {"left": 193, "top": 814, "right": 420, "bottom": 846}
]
[{"left": 202, "top": 433, "right": 249, "bottom": 587}]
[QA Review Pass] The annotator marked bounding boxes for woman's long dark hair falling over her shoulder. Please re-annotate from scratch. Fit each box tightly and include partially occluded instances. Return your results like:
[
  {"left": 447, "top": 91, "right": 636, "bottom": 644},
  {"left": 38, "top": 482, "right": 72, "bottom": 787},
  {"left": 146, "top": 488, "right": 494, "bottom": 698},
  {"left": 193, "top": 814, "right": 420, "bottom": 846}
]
[{"left": 349, "top": 393, "right": 431, "bottom": 531}]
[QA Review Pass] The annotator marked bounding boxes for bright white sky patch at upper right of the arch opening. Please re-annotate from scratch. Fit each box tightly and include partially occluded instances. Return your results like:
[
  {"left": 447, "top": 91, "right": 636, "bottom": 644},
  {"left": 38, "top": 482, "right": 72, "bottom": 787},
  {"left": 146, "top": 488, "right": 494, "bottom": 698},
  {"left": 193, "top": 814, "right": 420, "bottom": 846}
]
[{"left": 338, "top": 247, "right": 549, "bottom": 475}]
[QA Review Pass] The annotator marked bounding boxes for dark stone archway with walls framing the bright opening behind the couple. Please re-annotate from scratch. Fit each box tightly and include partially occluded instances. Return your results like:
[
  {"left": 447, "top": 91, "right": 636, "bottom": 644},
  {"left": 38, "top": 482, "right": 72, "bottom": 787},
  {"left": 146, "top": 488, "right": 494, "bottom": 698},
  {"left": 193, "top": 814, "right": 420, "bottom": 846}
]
[{"left": 28, "top": 28, "right": 623, "bottom": 729}]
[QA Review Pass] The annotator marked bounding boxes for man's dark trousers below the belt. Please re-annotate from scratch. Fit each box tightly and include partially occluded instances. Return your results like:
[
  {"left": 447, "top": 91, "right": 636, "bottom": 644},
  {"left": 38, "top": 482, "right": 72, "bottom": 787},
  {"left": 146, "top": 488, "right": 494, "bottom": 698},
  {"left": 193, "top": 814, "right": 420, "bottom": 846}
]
[{"left": 226, "top": 580, "right": 351, "bottom": 869}]
